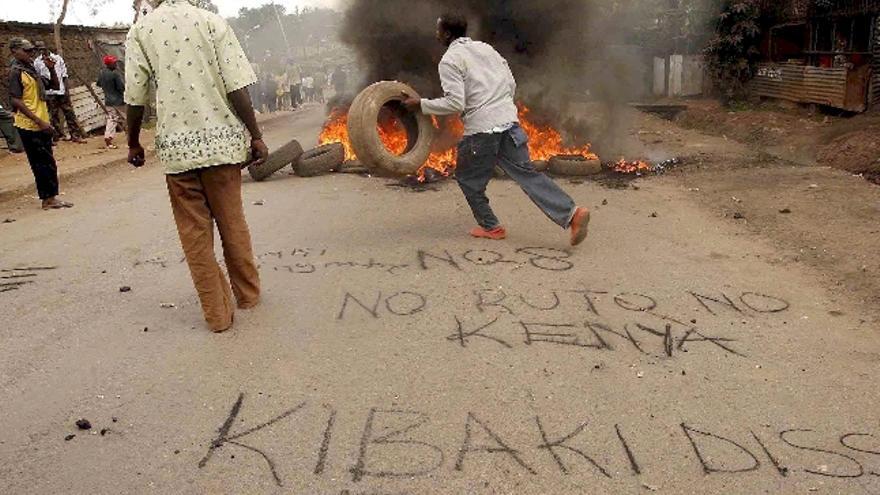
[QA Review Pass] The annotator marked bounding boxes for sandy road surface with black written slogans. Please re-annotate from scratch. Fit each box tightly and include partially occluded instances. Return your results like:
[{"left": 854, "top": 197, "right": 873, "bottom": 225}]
[{"left": 0, "top": 103, "right": 880, "bottom": 495}]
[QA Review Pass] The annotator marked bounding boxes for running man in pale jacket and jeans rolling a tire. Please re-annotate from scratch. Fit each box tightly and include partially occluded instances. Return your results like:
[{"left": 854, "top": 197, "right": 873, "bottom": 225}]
[{"left": 404, "top": 14, "right": 590, "bottom": 246}]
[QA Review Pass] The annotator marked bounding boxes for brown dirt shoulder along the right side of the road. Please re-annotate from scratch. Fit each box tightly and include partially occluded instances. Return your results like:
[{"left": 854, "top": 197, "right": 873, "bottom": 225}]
[{"left": 633, "top": 106, "right": 880, "bottom": 320}]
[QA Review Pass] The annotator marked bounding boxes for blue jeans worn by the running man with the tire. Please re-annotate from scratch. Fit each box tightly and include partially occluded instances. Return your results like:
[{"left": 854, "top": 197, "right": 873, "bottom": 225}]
[{"left": 455, "top": 125, "right": 575, "bottom": 230}]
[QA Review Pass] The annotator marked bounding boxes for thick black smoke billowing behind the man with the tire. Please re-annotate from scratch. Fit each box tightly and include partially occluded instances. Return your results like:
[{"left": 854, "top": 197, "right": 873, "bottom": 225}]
[{"left": 342, "top": 0, "right": 604, "bottom": 125}]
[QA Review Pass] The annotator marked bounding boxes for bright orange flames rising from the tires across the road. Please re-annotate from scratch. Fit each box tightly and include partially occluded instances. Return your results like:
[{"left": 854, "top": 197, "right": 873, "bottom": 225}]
[{"left": 318, "top": 103, "right": 598, "bottom": 178}]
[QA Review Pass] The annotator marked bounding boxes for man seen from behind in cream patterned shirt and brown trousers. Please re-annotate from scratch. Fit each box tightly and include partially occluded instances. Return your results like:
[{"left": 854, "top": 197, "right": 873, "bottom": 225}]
[{"left": 125, "top": 0, "right": 269, "bottom": 332}]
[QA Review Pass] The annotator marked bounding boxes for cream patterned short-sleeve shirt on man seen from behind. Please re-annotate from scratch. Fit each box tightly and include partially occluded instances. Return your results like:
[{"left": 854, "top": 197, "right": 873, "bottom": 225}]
[{"left": 125, "top": 0, "right": 256, "bottom": 174}]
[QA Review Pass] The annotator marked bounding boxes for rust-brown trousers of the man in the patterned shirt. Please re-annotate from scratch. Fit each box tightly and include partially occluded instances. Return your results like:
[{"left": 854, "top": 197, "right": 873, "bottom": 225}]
[{"left": 165, "top": 165, "right": 260, "bottom": 332}]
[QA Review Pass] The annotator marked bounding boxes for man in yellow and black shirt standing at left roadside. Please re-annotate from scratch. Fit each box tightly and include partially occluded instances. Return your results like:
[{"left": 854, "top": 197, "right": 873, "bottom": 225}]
[{"left": 9, "top": 38, "right": 73, "bottom": 210}]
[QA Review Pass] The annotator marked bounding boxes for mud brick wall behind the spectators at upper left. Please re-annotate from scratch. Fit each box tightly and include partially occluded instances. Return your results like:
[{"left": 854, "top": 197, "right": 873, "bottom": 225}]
[{"left": 0, "top": 22, "right": 128, "bottom": 108}]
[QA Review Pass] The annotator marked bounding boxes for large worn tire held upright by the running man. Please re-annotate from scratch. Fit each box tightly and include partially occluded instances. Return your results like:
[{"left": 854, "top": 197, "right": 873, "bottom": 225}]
[{"left": 348, "top": 81, "right": 434, "bottom": 175}]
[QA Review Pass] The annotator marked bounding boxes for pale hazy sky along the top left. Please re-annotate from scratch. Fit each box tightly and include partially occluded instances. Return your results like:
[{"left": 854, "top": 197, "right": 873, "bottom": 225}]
[{"left": 0, "top": 0, "right": 341, "bottom": 25}]
